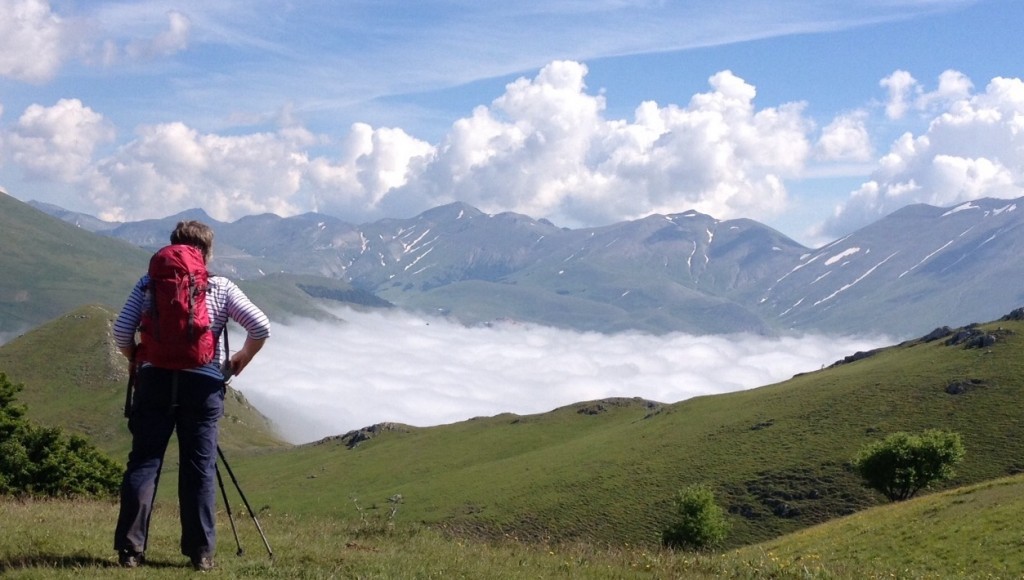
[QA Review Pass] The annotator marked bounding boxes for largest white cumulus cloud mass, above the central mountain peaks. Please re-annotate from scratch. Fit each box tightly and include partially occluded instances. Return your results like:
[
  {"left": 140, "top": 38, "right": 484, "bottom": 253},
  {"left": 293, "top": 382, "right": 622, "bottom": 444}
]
[{"left": 305, "top": 61, "right": 812, "bottom": 225}]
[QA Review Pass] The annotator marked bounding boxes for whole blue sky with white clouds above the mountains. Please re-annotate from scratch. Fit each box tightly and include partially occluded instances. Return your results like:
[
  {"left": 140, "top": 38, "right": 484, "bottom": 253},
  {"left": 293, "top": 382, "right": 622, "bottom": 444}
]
[{"left": 0, "top": 0, "right": 1024, "bottom": 246}]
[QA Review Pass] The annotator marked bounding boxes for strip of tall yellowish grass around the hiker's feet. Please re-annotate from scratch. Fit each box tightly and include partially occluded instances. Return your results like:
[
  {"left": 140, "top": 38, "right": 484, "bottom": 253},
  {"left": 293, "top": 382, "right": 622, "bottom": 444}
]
[{"left": 0, "top": 500, "right": 723, "bottom": 579}]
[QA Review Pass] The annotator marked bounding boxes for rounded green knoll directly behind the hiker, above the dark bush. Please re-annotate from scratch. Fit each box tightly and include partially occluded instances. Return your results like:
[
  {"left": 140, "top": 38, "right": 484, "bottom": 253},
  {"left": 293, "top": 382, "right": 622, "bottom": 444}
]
[{"left": 0, "top": 305, "right": 282, "bottom": 459}]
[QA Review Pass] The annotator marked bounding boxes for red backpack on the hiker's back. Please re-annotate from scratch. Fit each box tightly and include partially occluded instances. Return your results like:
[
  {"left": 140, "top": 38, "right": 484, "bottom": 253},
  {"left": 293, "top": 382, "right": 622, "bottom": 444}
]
[{"left": 137, "top": 244, "right": 214, "bottom": 370}]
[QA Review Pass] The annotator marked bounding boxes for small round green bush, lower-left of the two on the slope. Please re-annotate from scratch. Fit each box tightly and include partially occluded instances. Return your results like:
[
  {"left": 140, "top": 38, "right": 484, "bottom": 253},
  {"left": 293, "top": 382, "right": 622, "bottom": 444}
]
[{"left": 662, "top": 486, "right": 729, "bottom": 549}]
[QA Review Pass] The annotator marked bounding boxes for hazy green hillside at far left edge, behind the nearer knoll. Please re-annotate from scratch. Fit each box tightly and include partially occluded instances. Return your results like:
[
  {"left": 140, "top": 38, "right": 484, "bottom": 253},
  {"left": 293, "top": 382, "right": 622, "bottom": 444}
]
[{"left": 0, "top": 193, "right": 150, "bottom": 340}]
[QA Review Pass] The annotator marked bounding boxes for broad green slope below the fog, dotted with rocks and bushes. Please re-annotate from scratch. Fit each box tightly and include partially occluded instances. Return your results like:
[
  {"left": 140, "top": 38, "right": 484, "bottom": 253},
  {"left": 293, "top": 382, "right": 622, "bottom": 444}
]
[{"left": 222, "top": 322, "right": 1024, "bottom": 546}]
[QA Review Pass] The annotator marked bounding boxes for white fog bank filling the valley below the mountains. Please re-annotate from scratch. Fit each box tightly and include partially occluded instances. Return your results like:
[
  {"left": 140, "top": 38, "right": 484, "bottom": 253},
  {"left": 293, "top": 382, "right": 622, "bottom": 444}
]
[{"left": 234, "top": 309, "right": 891, "bottom": 443}]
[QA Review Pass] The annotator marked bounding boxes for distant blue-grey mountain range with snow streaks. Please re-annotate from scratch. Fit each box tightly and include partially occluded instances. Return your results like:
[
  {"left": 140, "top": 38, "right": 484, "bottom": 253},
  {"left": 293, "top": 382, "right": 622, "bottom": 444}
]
[{"left": 14, "top": 199, "right": 1024, "bottom": 338}]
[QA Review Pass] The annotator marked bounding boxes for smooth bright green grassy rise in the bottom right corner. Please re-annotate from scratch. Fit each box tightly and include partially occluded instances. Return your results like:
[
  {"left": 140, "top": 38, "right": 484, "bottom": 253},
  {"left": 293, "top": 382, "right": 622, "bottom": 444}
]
[{"left": 735, "top": 475, "right": 1024, "bottom": 578}]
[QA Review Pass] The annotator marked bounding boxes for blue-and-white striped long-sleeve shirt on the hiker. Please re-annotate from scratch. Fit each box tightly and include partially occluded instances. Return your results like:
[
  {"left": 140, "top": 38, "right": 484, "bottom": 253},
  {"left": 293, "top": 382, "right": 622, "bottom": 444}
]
[{"left": 114, "top": 275, "right": 270, "bottom": 378}]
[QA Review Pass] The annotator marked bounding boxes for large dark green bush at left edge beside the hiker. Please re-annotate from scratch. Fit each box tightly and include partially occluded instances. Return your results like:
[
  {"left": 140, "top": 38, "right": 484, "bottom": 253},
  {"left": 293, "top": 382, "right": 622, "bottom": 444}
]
[{"left": 0, "top": 373, "right": 122, "bottom": 497}]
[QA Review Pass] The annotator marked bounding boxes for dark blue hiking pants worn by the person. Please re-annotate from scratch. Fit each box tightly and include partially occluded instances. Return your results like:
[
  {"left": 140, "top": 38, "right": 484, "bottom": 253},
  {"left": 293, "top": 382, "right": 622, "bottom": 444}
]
[{"left": 114, "top": 367, "right": 224, "bottom": 558}]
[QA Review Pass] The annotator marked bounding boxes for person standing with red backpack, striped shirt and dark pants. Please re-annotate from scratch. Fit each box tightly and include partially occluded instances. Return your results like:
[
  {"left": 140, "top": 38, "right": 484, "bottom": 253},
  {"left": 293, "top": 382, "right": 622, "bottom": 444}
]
[{"left": 114, "top": 220, "right": 270, "bottom": 571}]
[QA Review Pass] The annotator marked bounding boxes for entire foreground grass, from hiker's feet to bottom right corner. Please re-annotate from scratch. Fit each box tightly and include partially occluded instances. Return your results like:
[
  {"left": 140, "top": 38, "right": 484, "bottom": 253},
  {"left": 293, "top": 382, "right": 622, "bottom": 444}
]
[{"left": 0, "top": 477, "right": 1024, "bottom": 580}]
